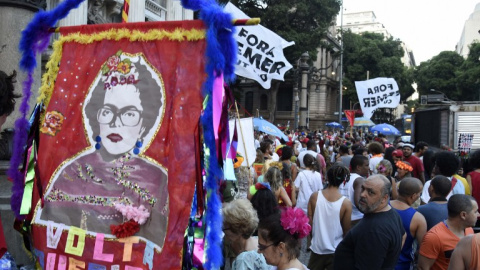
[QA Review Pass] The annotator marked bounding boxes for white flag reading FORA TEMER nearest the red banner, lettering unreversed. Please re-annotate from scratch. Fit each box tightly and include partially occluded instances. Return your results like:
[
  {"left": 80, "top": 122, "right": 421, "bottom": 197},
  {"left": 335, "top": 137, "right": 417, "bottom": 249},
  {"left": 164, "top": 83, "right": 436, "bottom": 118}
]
[{"left": 224, "top": 3, "right": 295, "bottom": 89}]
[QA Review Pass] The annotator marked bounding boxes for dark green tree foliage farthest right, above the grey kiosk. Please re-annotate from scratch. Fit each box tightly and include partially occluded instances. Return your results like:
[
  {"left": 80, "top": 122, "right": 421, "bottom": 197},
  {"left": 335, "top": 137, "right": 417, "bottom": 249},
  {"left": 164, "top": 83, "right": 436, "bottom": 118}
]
[{"left": 414, "top": 51, "right": 464, "bottom": 100}]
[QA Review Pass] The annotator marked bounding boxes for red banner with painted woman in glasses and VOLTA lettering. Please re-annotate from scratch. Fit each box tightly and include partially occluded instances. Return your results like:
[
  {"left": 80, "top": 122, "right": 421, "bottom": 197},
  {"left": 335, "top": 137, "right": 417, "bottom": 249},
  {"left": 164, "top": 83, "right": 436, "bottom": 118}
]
[{"left": 32, "top": 21, "right": 206, "bottom": 270}]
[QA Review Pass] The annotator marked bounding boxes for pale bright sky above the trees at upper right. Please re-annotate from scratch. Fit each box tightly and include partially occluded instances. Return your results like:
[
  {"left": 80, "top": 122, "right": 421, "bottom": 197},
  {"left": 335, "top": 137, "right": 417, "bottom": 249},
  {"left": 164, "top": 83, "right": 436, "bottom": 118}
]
[{"left": 343, "top": 0, "right": 480, "bottom": 65}]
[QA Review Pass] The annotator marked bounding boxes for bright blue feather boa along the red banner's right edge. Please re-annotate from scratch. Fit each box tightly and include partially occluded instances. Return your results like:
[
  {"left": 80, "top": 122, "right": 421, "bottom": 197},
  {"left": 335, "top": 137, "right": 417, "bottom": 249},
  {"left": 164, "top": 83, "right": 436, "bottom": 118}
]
[{"left": 182, "top": 0, "right": 237, "bottom": 270}]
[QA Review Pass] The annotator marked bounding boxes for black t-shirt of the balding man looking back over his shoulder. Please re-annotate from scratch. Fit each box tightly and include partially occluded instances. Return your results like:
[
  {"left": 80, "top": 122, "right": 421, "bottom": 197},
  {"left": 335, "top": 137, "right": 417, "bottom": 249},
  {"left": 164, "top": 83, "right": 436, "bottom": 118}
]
[{"left": 333, "top": 208, "right": 405, "bottom": 270}]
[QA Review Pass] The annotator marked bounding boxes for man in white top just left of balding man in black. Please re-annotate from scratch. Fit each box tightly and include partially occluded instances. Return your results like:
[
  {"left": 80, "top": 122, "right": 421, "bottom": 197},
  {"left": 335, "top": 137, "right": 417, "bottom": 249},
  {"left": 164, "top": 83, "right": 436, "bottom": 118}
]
[{"left": 339, "top": 155, "right": 370, "bottom": 226}]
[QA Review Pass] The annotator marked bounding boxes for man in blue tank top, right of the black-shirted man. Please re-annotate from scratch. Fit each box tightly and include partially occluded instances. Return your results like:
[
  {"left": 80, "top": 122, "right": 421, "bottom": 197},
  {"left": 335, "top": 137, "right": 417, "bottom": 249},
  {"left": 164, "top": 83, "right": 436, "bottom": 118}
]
[{"left": 390, "top": 177, "right": 427, "bottom": 270}]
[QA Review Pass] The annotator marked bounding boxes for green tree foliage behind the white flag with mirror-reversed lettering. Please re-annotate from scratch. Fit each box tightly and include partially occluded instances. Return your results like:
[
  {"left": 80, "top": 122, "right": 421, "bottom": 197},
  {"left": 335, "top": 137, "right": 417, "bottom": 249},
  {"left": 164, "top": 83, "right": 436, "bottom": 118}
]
[{"left": 343, "top": 31, "right": 414, "bottom": 102}]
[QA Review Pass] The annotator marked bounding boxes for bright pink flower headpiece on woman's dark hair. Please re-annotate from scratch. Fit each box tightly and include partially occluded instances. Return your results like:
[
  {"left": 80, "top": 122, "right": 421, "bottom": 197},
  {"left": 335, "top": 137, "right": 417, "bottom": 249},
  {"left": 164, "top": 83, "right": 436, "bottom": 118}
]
[{"left": 280, "top": 207, "right": 312, "bottom": 239}]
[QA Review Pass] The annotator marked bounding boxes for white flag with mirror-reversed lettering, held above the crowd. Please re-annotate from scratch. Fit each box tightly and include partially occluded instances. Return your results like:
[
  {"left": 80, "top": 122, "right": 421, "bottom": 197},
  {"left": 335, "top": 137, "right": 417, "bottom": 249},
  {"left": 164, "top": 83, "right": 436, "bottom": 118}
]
[{"left": 355, "top": 78, "right": 400, "bottom": 119}]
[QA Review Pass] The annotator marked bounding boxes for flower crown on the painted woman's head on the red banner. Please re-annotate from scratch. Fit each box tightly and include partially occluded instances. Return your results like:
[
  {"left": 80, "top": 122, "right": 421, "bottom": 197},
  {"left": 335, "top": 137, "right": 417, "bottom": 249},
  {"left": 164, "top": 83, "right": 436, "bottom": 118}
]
[{"left": 101, "top": 51, "right": 138, "bottom": 90}]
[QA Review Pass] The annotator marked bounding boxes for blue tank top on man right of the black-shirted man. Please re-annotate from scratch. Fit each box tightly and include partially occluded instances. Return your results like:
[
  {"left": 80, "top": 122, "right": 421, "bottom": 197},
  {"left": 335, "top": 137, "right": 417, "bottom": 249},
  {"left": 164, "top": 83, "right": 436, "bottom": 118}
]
[{"left": 394, "top": 207, "right": 417, "bottom": 270}]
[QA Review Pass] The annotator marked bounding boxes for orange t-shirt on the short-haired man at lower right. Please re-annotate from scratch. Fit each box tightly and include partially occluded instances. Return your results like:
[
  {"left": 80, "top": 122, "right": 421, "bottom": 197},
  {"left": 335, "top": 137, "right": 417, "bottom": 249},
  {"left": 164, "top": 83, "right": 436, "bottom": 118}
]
[{"left": 419, "top": 222, "right": 473, "bottom": 270}]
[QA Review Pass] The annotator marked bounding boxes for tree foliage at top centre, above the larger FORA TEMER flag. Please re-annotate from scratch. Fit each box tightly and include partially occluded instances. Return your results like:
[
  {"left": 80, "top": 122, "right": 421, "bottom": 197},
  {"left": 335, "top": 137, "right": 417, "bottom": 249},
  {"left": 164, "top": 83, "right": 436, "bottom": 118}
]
[{"left": 225, "top": 0, "right": 340, "bottom": 63}]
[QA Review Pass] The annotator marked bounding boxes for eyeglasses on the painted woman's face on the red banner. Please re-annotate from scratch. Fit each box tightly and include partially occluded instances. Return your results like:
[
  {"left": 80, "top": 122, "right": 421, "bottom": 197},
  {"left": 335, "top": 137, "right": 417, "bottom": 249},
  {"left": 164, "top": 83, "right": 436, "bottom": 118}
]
[{"left": 97, "top": 107, "right": 142, "bottom": 127}]
